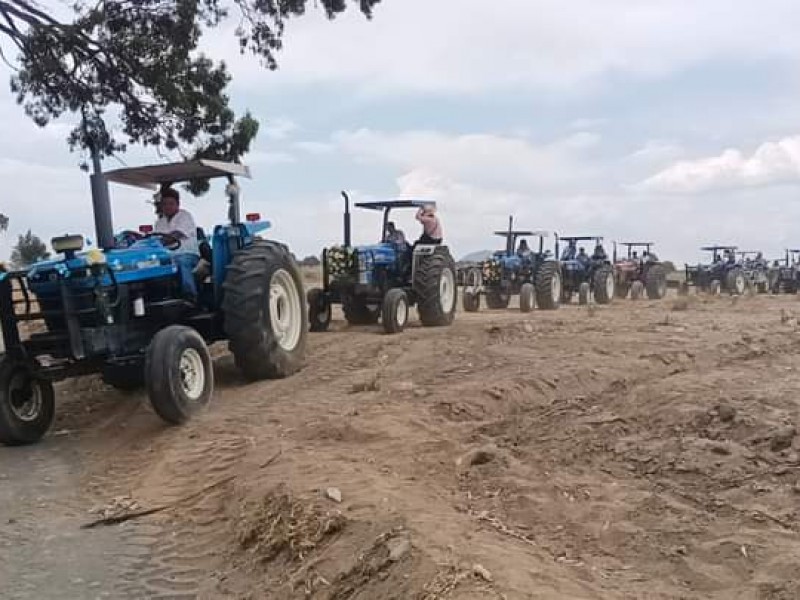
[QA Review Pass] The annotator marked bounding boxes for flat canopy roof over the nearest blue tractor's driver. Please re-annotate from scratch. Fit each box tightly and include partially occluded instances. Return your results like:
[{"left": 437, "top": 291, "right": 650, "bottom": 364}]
[{"left": 105, "top": 159, "right": 250, "bottom": 189}]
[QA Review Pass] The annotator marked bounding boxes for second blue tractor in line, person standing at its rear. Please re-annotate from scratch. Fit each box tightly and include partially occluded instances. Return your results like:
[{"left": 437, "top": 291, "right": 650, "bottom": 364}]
[{"left": 308, "top": 192, "right": 456, "bottom": 333}]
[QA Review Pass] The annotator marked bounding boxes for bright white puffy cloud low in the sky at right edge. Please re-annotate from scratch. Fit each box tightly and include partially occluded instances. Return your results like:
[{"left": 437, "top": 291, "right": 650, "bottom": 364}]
[{"left": 636, "top": 136, "right": 800, "bottom": 194}]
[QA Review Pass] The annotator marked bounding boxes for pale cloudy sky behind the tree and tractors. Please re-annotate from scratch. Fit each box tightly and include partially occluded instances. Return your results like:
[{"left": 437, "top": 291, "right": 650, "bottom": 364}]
[{"left": 0, "top": 0, "right": 800, "bottom": 262}]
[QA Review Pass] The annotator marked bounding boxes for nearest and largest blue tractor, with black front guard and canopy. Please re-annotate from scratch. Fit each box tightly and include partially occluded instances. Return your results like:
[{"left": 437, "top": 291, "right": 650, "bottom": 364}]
[{"left": 0, "top": 160, "right": 308, "bottom": 445}]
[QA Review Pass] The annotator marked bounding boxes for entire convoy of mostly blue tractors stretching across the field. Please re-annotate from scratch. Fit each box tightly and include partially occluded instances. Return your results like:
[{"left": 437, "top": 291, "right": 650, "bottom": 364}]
[{"left": 0, "top": 160, "right": 800, "bottom": 445}]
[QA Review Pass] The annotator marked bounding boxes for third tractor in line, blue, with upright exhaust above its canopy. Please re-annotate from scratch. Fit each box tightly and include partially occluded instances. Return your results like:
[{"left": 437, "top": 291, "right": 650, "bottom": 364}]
[{"left": 463, "top": 217, "right": 562, "bottom": 312}]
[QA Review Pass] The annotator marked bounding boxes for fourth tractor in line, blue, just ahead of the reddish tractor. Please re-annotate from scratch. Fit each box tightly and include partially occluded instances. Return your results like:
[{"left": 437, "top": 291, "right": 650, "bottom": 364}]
[{"left": 556, "top": 235, "right": 616, "bottom": 304}]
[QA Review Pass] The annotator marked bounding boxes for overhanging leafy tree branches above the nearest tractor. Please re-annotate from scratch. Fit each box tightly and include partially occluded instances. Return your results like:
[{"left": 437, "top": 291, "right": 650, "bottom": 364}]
[{"left": 0, "top": 0, "right": 380, "bottom": 160}]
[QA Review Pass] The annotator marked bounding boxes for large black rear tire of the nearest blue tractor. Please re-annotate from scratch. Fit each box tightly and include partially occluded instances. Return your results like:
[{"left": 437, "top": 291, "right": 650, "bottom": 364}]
[{"left": 222, "top": 240, "right": 309, "bottom": 380}]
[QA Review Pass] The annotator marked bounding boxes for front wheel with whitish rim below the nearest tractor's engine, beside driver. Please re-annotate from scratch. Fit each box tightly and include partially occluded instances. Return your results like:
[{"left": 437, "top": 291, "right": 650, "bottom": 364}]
[{"left": 144, "top": 325, "right": 214, "bottom": 425}]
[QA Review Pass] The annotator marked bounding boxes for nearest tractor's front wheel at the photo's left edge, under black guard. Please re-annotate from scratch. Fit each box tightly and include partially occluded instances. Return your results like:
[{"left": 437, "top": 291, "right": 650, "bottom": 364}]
[{"left": 0, "top": 356, "right": 56, "bottom": 446}]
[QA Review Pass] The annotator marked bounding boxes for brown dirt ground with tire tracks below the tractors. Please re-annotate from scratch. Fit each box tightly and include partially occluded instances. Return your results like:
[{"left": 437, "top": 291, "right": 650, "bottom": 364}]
[{"left": 0, "top": 290, "right": 800, "bottom": 600}]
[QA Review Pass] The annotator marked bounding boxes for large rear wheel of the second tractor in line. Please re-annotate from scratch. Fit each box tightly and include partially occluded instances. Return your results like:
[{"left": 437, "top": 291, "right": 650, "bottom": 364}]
[{"left": 413, "top": 246, "right": 458, "bottom": 327}]
